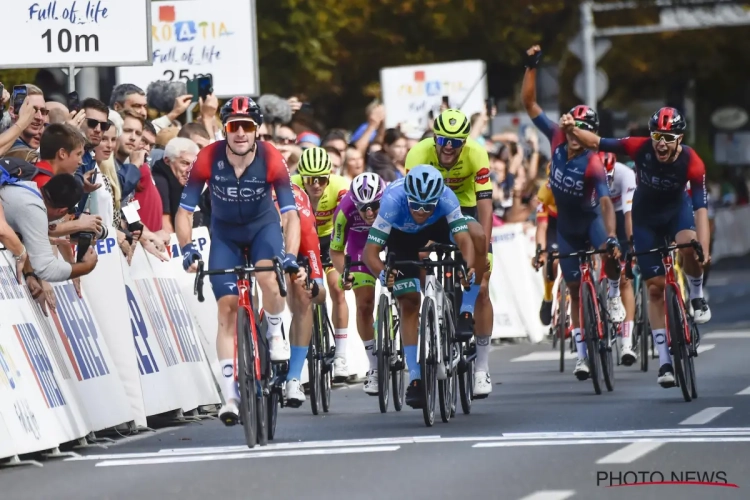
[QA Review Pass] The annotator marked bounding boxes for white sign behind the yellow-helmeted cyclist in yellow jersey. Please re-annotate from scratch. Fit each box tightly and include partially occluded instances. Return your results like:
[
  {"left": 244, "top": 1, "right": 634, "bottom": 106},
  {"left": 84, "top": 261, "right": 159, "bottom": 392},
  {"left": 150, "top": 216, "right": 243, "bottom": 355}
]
[{"left": 380, "top": 61, "right": 487, "bottom": 130}]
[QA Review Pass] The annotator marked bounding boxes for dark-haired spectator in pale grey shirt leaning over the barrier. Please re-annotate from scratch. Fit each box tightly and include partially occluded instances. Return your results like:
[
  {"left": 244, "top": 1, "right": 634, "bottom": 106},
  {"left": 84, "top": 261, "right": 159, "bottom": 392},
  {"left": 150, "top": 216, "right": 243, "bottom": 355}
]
[{"left": 0, "top": 174, "right": 97, "bottom": 282}]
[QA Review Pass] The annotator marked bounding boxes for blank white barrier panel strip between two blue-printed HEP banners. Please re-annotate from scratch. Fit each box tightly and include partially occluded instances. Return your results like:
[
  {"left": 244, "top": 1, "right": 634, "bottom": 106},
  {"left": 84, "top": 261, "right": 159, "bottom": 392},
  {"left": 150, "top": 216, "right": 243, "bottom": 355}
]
[{"left": 81, "top": 238, "right": 146, "bottom": 427}]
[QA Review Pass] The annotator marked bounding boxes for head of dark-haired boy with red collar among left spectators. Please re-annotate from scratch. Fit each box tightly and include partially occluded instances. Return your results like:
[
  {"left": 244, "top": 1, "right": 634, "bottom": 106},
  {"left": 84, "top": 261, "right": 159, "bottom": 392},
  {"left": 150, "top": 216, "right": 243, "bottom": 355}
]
[{"left": 32, "top": 123, "right": 84, "bottom": 189}]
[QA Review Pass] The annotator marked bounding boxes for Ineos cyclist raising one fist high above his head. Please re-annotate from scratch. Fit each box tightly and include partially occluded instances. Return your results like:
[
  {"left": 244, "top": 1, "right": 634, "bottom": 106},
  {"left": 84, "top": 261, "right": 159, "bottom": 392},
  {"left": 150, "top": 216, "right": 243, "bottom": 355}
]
[{"left": 521, "top": 45, "right": 625, "bottom": 380}]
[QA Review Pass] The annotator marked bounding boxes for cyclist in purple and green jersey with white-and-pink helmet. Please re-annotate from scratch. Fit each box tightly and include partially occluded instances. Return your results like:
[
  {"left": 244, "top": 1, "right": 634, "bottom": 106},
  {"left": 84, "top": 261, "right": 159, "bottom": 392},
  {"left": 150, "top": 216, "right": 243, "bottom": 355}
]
[{"left": 330, "top": 172, "right": 385, "bottom": 396}]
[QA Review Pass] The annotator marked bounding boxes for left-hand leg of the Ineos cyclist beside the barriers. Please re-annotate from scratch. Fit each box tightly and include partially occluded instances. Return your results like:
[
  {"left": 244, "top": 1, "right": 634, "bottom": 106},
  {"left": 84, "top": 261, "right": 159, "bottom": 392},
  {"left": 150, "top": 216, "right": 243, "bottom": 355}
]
[{"left": 208, "top": 228, "right": 242, "bottom": 421}]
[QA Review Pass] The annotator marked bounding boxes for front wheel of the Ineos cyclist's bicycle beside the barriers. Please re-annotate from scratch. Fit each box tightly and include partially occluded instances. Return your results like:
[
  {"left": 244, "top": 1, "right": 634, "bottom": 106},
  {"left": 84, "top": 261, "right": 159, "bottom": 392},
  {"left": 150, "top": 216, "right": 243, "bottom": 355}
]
[{"left": 237, "top": 307, "right": 258, "bottom": 448}]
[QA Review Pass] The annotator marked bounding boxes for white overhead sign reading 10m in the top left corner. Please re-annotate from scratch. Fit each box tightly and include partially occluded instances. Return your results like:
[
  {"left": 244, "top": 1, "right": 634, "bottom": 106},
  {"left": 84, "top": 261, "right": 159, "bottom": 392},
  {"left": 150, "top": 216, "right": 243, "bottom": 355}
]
[{"left": 0, "top": 0, "right": 151, "bottom": 68}]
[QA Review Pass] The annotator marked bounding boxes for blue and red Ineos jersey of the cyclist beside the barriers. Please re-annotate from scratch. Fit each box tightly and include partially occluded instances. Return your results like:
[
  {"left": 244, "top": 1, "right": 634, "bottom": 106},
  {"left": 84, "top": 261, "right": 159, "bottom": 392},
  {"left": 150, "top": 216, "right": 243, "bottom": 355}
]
[{"left": 180, "top": 141, "right": 295, "bottom": 225}]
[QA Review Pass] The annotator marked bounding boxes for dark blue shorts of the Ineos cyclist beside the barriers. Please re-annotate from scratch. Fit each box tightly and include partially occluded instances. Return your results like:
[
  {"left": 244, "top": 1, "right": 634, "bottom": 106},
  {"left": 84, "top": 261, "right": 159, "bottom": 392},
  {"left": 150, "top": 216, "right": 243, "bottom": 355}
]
[{"left": 208, "top": 216, "right": 284, "bottom": 301}]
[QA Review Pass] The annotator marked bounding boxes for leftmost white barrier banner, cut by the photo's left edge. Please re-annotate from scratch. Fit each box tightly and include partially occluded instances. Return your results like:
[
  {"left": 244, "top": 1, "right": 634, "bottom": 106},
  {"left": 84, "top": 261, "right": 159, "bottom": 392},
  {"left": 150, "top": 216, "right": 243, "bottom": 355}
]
[{"left": 0, "top": 252, "right": 62, "bottom": 456}]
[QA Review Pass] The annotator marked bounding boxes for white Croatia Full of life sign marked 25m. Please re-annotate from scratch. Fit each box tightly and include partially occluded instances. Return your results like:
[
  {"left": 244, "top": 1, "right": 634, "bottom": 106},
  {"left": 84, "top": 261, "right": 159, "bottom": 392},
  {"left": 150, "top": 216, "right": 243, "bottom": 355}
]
[{"left": 117, "top": 0, "right": 260, "bottom": 97}]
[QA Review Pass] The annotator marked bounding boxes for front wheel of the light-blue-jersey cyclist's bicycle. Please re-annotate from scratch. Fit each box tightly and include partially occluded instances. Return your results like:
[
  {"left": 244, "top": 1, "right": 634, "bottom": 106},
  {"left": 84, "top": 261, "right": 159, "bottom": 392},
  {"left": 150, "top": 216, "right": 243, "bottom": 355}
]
[{"left": 419, "top": 297, "right": 438, "bottom": 427}]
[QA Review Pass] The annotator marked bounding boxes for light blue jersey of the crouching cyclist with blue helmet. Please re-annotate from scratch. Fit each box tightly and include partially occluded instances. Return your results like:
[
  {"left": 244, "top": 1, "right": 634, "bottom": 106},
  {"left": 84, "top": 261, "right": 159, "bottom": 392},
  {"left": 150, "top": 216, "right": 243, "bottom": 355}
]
[{"left": 367, "top": 179, "right": 469, "bottom": 247}]
